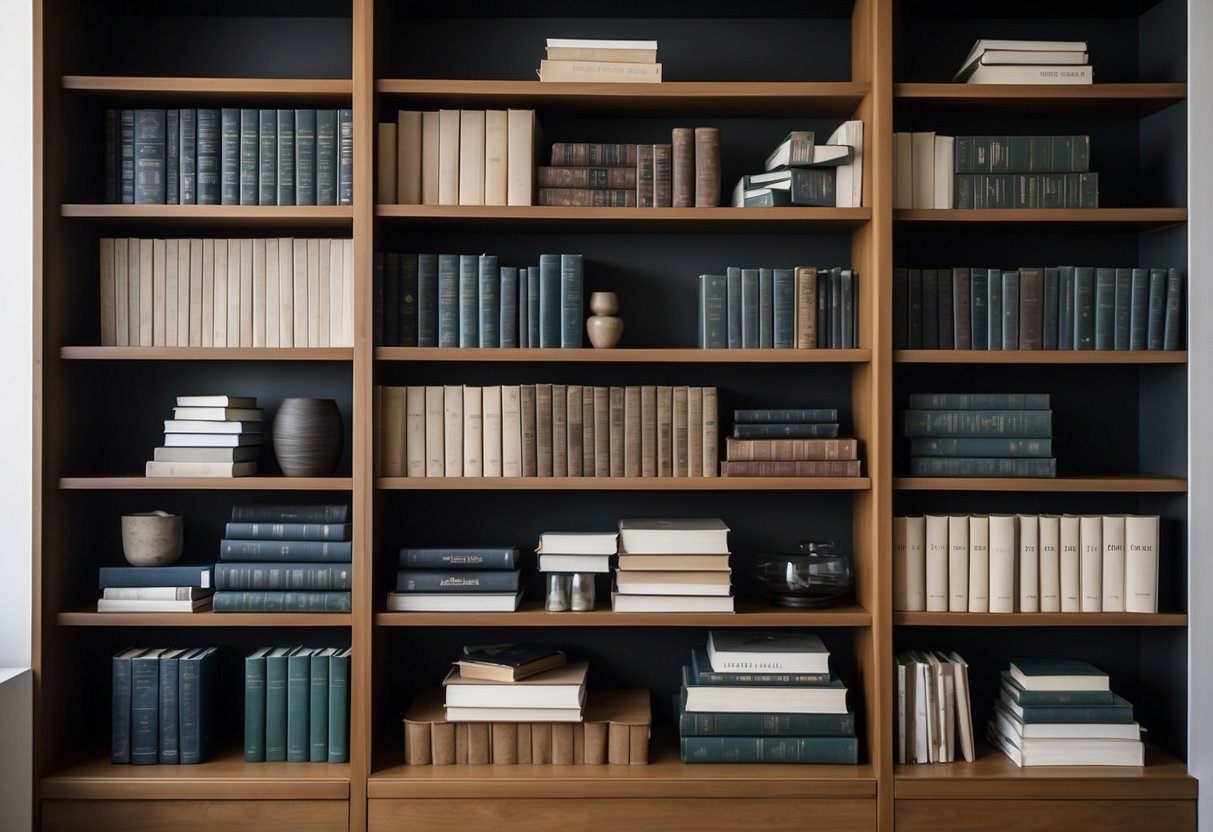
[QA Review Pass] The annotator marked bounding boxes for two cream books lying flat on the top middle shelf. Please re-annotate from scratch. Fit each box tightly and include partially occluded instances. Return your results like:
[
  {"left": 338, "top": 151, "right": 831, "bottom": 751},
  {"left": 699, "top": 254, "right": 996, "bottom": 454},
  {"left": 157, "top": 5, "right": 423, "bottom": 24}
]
[{"left": 537, "top": 38, "right": 661, "bottom": 84}]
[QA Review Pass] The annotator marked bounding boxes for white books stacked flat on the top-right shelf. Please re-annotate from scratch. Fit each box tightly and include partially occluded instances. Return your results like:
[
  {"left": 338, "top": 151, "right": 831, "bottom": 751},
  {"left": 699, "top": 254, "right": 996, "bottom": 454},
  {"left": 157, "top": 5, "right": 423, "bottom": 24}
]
[{"left": 952, "top": 38, "right": 1094, "bottom": 84}]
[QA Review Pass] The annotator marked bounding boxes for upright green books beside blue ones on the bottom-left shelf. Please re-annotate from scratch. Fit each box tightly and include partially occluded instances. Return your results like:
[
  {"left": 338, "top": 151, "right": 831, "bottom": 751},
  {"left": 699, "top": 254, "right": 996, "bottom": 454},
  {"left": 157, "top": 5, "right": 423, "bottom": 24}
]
[{"left": 244, "top": 646, "right": 351, "bottom": 763}]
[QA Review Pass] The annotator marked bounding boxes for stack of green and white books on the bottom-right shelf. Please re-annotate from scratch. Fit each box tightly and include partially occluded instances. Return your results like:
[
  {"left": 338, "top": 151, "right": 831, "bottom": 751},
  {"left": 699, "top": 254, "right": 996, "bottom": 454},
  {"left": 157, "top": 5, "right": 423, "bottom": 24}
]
[{"left": 987, "top": 659, "right": 1145, "bottom": 767}]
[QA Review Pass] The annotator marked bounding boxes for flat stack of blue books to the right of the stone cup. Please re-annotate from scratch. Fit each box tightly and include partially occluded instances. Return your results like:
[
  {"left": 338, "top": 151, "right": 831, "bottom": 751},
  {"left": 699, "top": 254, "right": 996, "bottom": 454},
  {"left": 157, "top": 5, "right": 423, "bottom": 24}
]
[{"left": 215, "top": 503, "right": 353, "bottom": 612}]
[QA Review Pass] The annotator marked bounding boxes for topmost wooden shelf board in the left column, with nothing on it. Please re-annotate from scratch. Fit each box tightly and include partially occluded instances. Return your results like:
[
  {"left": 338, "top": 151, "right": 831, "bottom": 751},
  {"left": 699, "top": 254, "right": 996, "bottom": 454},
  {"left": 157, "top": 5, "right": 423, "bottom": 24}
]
[{"left": 63, "top": 75, "right": 354, "bottom": 101}]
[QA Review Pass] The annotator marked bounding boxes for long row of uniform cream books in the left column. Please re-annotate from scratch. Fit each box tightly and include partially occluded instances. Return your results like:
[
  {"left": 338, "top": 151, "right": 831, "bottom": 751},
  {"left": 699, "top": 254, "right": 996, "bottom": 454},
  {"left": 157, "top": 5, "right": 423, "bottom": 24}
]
[{"left": 99, "top": 237, "right": 354, "bottom": 347}]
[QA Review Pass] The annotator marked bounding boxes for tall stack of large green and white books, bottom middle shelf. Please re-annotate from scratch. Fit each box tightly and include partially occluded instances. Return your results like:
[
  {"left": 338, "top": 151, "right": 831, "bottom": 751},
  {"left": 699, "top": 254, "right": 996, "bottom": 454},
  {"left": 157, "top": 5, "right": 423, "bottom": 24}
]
[{"left": 674, "top": 629, "right": 859, "bottom": 764}]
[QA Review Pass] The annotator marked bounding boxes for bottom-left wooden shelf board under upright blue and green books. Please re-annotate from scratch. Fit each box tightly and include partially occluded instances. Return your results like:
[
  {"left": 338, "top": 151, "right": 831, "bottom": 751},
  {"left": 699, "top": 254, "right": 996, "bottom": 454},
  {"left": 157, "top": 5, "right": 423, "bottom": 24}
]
[{"left": 39, "top": 747, "right": 349, "bottom": 800}]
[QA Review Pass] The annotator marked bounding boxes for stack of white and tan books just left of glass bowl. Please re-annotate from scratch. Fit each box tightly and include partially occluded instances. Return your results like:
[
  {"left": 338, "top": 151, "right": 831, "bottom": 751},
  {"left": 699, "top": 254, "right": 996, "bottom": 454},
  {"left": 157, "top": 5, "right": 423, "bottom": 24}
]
[{"left": 611, "top": 518, "right": 733, "bottom": 612}]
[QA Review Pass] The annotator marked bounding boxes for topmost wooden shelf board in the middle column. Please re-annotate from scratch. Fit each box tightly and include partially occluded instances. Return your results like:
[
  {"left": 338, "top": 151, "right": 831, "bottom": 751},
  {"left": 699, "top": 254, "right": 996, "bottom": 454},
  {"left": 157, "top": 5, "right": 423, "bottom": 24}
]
[{"left": 375, "top": 79, "right": 871, "bottom": 118}]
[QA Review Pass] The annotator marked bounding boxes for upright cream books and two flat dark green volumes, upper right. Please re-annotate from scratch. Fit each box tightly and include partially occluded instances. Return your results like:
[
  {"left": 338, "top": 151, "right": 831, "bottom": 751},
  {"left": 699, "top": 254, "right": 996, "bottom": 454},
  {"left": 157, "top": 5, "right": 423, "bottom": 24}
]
[{"left": 893, "top": 131, "right": 1099, "bottom": 209}]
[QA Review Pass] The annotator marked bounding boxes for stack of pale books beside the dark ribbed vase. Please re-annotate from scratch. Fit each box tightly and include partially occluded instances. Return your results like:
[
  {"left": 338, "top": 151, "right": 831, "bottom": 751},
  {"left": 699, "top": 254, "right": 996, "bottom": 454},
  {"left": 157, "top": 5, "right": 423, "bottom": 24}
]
[{"left": 144, "top": 395, "right": 261, "bottom": 477}]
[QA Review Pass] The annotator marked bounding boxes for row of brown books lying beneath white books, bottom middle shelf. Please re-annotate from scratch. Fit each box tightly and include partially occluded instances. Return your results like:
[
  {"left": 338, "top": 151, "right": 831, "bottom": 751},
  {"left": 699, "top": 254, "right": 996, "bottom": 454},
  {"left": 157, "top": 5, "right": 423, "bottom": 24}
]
[{"left": 404, "top": 688, "right": 653, "bottom": 765}]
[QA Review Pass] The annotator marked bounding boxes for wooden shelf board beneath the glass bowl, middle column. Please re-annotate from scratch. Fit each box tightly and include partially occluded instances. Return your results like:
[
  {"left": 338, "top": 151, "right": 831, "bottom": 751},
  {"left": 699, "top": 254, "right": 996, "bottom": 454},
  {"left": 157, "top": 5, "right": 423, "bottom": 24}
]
[{"left": 375, "top": 598, "right": 872, "bottom": 628}]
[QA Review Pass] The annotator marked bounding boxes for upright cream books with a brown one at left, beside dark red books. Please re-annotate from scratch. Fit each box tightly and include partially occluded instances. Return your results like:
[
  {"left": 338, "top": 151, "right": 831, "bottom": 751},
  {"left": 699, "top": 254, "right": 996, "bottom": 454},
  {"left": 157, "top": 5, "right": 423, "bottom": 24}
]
[{"left": 375, "top": 109, "right": 537, "bottom": 205}]
